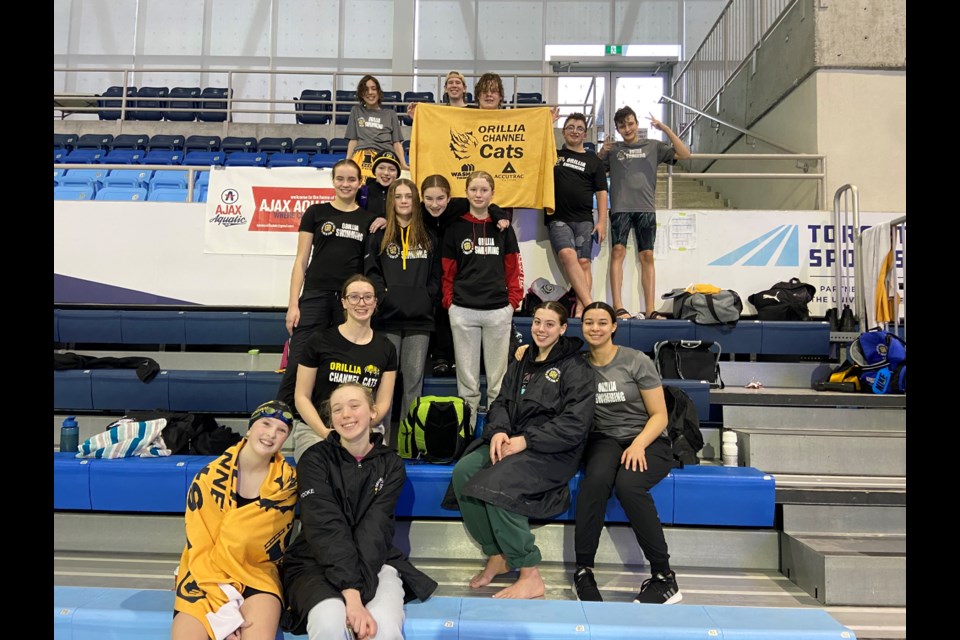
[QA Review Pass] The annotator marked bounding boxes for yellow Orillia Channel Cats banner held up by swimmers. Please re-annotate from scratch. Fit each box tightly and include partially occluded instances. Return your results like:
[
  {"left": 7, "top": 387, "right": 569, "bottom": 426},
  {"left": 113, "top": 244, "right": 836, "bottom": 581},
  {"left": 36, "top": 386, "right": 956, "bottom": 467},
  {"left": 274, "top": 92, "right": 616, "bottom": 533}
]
[{"left": 410, "top": 104, "right": 557, "bottom": 213}]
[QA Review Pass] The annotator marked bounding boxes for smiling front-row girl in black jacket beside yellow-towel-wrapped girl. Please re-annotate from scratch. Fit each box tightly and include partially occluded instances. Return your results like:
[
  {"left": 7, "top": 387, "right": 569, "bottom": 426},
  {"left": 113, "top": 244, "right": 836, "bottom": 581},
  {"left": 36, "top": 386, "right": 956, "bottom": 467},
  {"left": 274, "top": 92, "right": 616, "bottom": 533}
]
[{"left": 280, "top": 382, "right": 437, "bottom": 640}]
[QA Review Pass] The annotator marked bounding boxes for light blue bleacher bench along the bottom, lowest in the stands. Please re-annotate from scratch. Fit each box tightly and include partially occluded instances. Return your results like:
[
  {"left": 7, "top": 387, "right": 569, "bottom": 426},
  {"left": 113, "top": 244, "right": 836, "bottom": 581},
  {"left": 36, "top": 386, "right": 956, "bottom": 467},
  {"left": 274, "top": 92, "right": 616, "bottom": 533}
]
[{"left": 53, "top": 586, "right": 856, "bottom": 640}]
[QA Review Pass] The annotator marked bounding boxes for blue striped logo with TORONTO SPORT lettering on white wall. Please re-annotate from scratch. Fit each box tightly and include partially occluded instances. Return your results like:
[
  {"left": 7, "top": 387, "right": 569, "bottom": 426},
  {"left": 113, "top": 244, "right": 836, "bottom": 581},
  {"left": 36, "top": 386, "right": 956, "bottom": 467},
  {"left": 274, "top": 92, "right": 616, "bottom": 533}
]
[{"left": 709, "top": 224, "right": 905, "bottom": 268}]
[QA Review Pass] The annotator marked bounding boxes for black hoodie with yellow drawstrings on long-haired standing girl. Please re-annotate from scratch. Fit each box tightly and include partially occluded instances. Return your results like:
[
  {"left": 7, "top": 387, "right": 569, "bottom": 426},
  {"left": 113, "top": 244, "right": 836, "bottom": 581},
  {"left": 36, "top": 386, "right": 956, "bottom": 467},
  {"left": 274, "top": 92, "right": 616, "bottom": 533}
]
[{"left": 364, "top": 228, "right": 443, "bottom": 331}]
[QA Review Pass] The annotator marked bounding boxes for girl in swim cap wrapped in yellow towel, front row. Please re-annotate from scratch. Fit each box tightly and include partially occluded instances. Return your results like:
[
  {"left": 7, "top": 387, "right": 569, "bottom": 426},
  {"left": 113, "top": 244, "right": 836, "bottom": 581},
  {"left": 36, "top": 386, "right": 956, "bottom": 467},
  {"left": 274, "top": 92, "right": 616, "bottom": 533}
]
[{"left": 171, "top": 400, "right": 297, "bottom": 640}]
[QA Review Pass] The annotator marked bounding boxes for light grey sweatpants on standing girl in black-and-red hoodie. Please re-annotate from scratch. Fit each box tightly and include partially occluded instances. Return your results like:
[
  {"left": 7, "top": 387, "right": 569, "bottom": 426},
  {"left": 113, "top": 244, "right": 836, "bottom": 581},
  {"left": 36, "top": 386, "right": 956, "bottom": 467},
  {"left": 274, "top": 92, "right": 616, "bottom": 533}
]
[{"left": 450, "top": 304, "right": 513, "bottom": 427}]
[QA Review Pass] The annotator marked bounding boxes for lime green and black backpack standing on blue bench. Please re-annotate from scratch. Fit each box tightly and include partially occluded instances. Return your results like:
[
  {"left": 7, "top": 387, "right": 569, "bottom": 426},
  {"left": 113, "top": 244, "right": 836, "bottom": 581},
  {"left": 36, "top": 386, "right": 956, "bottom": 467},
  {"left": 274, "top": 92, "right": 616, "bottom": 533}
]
[{"left": 397, "top": 396, "right": 473, "bottom": 464}]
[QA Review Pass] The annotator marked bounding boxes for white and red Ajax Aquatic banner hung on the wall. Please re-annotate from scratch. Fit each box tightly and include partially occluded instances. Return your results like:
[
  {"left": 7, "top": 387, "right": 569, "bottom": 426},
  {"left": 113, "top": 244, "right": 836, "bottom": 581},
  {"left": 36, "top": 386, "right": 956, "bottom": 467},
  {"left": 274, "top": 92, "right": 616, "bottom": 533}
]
[{"left": 204, "top": 167, "right": 334, "bottom": 256}]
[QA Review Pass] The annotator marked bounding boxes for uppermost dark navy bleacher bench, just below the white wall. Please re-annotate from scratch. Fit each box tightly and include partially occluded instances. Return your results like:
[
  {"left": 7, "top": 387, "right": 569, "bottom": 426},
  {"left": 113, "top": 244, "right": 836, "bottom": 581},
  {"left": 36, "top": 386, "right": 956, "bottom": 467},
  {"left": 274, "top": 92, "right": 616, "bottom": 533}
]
[{"left": 53, "top": 308, "right": 830, "bottom": 356}]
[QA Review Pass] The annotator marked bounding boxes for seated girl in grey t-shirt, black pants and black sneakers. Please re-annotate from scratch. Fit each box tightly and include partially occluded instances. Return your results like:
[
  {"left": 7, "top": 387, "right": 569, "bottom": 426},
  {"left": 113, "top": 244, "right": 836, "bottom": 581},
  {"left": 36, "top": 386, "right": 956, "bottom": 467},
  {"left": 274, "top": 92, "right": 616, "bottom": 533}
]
[{"left": 573, "top": 302, "right": 683, "bottom": 604}]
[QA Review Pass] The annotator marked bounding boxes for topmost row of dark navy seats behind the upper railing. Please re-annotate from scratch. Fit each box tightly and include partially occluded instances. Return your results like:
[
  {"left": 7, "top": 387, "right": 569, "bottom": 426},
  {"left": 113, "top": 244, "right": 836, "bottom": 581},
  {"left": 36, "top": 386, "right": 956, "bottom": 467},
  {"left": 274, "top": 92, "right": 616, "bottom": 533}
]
[{"left": 97, "top": 86, "right": 544, "bottom": 126}]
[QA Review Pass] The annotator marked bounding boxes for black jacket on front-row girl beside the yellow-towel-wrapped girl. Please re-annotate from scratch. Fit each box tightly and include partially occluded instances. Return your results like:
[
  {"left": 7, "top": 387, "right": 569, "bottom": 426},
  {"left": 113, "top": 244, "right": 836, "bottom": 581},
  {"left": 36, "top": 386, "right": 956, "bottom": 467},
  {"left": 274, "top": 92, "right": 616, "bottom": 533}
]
[{"left": 281, "top": 432, "right": 437, "bottom": 634}]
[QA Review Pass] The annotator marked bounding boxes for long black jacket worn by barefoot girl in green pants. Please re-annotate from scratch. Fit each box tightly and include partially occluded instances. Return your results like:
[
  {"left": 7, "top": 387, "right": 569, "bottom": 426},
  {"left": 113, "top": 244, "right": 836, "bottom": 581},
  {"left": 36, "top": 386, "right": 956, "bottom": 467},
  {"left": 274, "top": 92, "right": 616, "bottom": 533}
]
[{"left": 443, "top": 337, "right": 596, "bottom": 518}]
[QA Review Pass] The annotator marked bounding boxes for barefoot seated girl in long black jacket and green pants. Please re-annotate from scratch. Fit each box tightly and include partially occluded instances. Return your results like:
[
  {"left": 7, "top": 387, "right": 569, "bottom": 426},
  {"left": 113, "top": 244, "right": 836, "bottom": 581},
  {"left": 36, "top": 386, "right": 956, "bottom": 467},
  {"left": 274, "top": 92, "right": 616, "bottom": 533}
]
[{"left": 443, "top": 302, "right": 594, "bottom": 599}]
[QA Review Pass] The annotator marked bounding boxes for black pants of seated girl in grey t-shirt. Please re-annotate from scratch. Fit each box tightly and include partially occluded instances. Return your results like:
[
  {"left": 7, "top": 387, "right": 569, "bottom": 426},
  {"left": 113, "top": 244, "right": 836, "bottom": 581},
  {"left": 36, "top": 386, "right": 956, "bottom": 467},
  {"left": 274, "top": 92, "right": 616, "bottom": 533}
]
[{"left": 573, "top": 433, "right": 674, "bottom": 573}]
